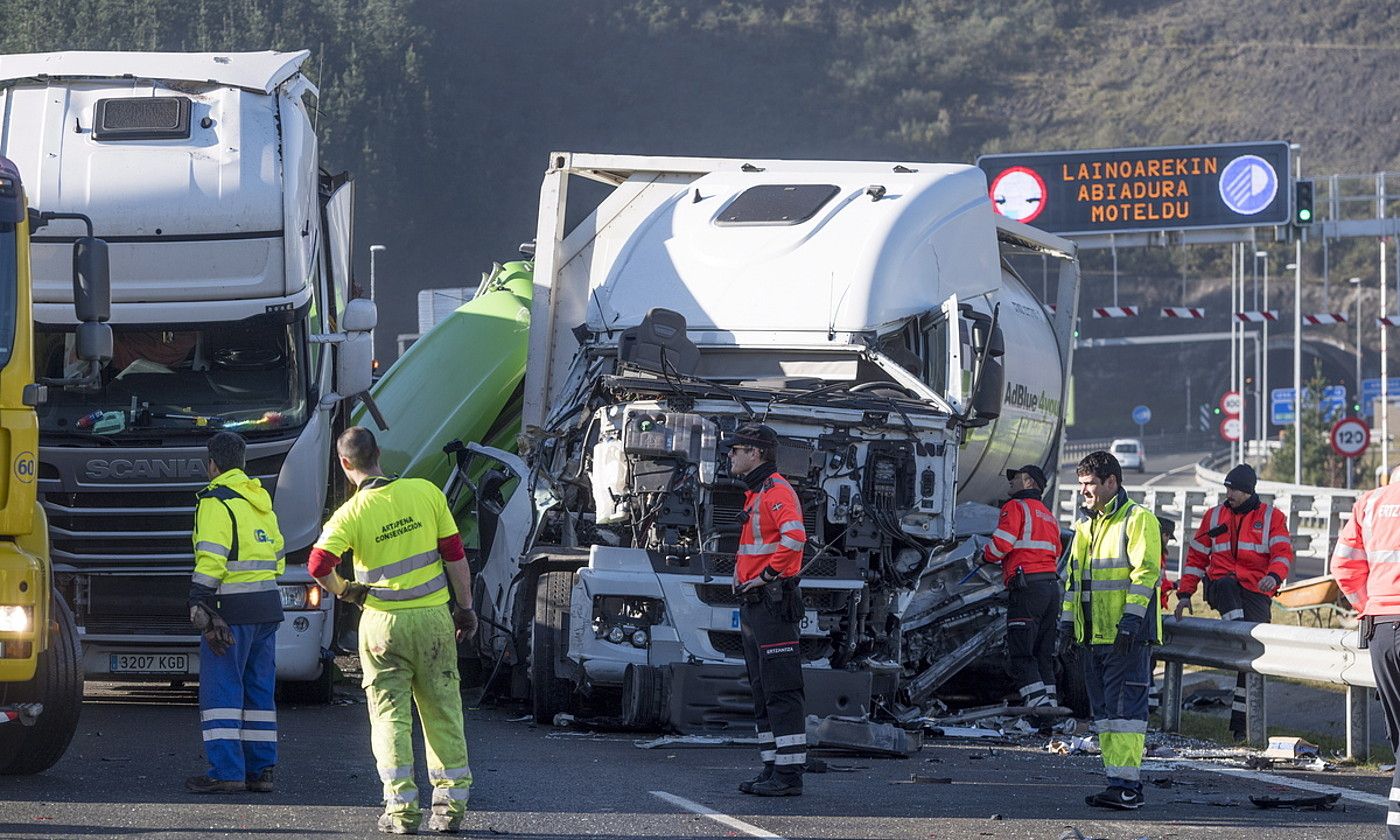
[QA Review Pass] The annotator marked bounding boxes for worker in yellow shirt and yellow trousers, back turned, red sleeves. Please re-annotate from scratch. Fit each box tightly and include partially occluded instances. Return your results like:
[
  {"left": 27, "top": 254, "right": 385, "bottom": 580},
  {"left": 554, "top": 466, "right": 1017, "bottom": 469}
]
[{"left": 309, "top": 426, "right": 477, "bottom": 834}]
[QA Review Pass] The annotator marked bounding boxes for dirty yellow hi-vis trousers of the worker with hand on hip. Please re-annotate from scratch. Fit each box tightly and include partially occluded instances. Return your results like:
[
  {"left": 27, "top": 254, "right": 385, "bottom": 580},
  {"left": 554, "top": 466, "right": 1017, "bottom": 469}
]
[{"left": 360, "top": 606, "right": 472, "bottom": 827}]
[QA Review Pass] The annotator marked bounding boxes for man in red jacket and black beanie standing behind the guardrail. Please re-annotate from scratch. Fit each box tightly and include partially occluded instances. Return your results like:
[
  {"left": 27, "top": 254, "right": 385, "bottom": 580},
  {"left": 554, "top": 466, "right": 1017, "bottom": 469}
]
[{"left": 1176, "top": 463, "right": 1294, "bottom": 741}]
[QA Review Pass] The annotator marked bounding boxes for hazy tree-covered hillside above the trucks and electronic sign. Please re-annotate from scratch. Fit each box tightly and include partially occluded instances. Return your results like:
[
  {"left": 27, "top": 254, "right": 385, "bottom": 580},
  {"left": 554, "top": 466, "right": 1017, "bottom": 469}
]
[{"left": 0, "top": 0, "right": 1400, "bottom": 366}]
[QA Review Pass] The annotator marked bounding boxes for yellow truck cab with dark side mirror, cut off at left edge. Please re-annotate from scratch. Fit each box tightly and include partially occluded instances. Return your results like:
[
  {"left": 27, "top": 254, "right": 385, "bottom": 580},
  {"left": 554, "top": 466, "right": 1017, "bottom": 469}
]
[{"left": 0, "top": 157, "right": 112, "bottom": 774}]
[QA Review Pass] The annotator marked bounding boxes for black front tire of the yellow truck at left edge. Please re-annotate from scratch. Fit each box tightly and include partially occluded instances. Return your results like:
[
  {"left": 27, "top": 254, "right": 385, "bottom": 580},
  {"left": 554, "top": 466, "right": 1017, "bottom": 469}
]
[{"left": 0, "top": 594, "right": 83, "bottom": 776}]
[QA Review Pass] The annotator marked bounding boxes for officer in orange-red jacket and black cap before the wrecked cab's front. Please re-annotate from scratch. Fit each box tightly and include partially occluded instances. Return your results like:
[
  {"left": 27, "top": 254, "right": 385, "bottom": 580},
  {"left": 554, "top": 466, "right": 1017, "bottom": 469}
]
[{"left": 729, "top": 424, "right": 806, "bottom": 797}]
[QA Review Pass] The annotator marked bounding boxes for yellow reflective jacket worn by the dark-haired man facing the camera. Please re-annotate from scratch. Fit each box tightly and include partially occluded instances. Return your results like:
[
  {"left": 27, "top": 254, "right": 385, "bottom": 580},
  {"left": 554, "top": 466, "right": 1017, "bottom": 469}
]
[{"left": 1060, "top": 491, "right": 1162, "bottom": 644}]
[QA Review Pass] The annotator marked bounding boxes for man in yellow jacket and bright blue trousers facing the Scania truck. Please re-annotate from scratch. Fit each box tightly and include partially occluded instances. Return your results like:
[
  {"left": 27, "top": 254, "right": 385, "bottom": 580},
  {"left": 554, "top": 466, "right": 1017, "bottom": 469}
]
[{"left": 185, "top": 431, "right": 286, "bottom": 794}]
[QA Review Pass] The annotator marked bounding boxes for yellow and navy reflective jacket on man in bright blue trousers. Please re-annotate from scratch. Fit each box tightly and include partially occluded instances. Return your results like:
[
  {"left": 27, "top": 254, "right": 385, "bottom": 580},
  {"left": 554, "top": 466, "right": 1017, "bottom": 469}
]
[{"left": 190, "top": 469, "right": 287, "bottom": 624}]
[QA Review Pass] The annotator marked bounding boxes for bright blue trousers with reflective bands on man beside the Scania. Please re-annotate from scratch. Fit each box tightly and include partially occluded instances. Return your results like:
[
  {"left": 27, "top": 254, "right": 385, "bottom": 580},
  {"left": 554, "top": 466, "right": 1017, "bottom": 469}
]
[{"left": 199, "top": 622, "right": 281, "bottom": 781}]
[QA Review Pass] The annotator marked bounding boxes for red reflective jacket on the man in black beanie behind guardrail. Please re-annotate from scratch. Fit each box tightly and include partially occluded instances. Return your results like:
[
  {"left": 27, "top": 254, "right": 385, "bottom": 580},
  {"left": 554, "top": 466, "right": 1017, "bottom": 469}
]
[{"left": 1176, "top": 503, "right": 1294, "bottom": 598}]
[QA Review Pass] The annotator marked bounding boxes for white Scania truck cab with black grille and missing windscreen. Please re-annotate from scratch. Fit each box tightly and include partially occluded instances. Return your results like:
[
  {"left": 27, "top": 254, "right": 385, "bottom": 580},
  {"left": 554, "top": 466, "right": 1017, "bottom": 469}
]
[{"left": 0, "top": 50, "right": 375, "bottom": 699}]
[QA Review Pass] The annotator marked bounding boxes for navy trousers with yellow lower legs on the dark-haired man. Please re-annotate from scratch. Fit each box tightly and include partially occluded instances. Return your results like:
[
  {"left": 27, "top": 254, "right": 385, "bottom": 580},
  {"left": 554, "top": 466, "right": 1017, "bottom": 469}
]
[{"left": 1084, "top": 643, "right": 1152, "bottom": 791}]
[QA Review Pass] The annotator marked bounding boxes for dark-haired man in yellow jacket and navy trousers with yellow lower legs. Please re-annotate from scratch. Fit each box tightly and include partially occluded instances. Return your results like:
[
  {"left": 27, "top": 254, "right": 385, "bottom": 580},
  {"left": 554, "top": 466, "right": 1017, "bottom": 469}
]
[{"left": 1060, "top": 452, "right": 1162, "bottom": 811}]
